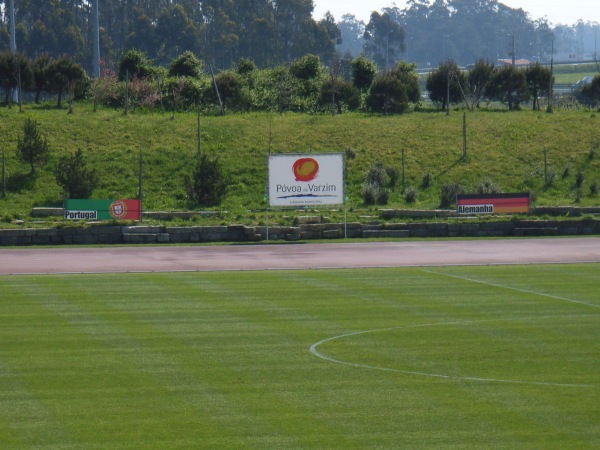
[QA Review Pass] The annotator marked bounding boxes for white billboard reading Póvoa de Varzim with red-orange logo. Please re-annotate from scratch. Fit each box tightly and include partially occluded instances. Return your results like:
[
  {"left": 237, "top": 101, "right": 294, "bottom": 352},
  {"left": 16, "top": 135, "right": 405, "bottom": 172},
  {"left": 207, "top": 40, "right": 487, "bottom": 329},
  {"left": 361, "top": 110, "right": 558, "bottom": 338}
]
[{"left": 269, "top": 153, "right": 344, "bottom": 206}]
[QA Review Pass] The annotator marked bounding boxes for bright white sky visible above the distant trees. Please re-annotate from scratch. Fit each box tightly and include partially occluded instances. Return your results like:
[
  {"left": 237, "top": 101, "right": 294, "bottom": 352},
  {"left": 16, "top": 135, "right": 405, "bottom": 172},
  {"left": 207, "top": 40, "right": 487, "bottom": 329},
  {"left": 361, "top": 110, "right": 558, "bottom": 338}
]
[{"left": 313, "top": 0, "right": 600, "bottom": 26}]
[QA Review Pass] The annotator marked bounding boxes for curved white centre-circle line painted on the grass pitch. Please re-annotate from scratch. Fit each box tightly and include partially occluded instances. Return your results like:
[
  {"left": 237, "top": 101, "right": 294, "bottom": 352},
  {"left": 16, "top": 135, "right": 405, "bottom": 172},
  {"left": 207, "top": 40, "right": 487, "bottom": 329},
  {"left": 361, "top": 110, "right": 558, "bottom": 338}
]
[{"left": 310, "top": 314, "right": 600, "bottom": 388}]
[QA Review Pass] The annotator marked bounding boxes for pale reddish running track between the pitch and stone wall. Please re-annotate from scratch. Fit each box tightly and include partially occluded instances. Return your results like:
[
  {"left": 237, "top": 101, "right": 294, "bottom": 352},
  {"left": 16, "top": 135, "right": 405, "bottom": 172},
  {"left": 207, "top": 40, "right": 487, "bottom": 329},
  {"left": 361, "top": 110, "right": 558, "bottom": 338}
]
[{"left": 0, "top": 237, "right": 600, "bottom": 275}]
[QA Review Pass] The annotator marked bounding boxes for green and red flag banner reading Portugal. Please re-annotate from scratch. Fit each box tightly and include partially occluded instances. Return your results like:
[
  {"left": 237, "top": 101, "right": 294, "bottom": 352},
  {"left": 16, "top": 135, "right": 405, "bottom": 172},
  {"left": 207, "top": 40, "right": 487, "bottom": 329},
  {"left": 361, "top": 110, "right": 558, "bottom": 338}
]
[{"left": 63, "top": 199, "right": 142, "bottom": 220}]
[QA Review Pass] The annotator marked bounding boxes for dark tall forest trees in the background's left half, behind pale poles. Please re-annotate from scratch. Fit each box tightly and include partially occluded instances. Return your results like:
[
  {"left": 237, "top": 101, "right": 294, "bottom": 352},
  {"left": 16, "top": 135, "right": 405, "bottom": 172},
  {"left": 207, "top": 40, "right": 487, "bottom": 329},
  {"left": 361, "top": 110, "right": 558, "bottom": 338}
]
[{"left": 0, "top": 0, "right": 339, "bottom": 70}]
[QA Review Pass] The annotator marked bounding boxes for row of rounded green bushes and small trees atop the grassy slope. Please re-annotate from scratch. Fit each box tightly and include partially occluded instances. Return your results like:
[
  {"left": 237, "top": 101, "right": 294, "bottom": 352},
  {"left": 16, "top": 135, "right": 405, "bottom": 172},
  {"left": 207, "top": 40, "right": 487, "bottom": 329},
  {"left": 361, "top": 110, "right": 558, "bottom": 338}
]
[{"left": 0, "top": 50, "right": 600, "bottom": 114}]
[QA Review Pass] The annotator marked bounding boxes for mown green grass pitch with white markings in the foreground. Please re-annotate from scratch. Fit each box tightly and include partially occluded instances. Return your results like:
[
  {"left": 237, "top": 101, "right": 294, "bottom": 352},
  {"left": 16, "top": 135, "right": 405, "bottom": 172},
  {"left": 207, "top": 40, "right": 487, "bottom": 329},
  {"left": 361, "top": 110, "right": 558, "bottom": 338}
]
[{"left": 0, "top": 264, "right": 600, "bottom": 449}]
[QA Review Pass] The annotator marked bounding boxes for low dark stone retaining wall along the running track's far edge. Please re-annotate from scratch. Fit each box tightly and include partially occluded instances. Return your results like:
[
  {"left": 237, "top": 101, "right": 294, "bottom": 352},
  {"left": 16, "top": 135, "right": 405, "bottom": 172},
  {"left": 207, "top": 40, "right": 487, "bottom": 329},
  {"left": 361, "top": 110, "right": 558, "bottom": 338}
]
[{"left": 0, "top": 219, "right": 600, "bottom": 246}]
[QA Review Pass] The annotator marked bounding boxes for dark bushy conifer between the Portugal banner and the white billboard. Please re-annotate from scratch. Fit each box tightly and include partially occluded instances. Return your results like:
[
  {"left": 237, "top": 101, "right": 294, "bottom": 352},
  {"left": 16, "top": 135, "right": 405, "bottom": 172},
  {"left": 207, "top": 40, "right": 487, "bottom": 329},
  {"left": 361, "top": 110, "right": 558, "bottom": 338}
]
[{"left": 184, "top": 153, "right": 231, "bottom": 206}]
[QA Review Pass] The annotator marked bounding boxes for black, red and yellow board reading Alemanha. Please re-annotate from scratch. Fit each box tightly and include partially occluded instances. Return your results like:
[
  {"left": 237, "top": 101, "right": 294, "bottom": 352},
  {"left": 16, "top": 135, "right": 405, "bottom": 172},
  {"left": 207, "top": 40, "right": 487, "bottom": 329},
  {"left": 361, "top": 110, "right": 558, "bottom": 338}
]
[{"left": 456, "top": 193, "right": 530, "bottom": 215}]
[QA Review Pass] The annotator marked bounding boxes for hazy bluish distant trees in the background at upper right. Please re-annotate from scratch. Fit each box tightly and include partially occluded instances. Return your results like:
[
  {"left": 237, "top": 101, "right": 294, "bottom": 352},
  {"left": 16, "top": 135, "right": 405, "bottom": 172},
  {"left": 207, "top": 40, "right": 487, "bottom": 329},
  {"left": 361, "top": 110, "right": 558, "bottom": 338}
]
[{"left": 338, "top": 0, "right": 600, "bottom": 67}]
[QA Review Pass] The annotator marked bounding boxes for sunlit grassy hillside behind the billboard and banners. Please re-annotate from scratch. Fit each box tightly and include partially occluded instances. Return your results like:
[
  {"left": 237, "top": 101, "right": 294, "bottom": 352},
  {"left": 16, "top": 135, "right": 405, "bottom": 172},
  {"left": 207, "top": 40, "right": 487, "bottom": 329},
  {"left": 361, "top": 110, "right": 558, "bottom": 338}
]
[{"left": 0, "top": 104, "right": 600, "bottom": 225}]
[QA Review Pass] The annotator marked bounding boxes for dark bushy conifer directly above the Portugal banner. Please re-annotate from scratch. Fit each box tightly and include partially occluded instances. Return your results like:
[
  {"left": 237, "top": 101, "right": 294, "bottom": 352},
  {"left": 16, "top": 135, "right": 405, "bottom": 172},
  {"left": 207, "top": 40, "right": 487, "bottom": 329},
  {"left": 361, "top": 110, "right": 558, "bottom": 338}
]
[{"left": 54, "top": 149, "right": 98, "bottom": 198}]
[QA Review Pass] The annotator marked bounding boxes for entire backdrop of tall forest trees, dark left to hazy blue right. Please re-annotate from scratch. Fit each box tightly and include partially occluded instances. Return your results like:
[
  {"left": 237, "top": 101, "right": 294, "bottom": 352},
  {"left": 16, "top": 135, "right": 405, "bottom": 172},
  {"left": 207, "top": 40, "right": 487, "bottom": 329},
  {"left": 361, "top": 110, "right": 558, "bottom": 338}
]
[{"left": 0, "top": 0, "right": 600, "bottom": 78}]
